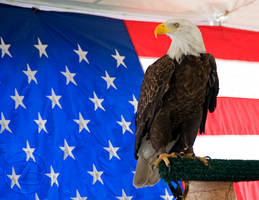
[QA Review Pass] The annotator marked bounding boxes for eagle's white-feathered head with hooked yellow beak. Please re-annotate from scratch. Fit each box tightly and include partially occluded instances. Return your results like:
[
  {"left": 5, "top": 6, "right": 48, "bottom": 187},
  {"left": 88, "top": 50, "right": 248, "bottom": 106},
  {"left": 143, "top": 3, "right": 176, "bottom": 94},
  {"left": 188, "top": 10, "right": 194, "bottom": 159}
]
[{"left": 155, "top": 19, "right": 205, "bottom": 62}]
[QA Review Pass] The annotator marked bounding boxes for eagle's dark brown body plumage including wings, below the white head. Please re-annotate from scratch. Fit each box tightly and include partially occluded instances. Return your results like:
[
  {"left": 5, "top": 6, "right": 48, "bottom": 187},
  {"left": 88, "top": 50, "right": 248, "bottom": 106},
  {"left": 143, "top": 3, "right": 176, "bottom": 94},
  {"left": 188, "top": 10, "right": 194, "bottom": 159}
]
[{"left": 135, "top": 54, "right": 218, "bottom": 158}]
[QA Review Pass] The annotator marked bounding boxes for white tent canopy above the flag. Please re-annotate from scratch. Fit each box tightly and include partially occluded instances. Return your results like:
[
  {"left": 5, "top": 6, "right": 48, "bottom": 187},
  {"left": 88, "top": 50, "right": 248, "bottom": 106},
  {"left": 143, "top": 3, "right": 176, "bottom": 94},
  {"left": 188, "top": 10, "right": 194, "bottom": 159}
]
[{"left": 0, "top": 0, "right": 259, "bottom": 31}]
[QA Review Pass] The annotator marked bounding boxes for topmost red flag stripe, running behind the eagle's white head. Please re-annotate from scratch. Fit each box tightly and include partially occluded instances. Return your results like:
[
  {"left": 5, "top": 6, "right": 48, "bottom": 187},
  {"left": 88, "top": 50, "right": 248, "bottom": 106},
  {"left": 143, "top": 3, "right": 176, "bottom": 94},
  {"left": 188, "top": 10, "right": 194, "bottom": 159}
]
[{"left": 125, "top": 20, "right": 259, "bottom": 61}]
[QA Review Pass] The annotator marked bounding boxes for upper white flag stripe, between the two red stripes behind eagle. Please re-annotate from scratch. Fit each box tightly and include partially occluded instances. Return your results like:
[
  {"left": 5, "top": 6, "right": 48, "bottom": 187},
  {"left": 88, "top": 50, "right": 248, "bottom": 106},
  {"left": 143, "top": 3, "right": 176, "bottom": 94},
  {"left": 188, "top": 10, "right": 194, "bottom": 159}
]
[{"left": 140, "top": 57, "right": 259, "bottom": 99}]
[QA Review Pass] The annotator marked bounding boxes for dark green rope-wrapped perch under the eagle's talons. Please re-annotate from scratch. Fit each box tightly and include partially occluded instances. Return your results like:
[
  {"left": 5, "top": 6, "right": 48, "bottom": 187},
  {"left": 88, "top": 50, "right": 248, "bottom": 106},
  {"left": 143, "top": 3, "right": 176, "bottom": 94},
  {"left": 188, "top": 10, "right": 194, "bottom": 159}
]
[{"left": 159, "top": 158, "right": 259, "bottom": 183}]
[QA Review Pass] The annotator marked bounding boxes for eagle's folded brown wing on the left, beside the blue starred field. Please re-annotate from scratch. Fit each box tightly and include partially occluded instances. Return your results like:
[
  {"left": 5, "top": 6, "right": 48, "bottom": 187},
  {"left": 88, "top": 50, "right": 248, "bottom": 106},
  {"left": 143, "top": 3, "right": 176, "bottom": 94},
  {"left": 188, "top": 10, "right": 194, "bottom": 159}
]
[{"left": 135, "top": 55, "right": 175, "bottom": 159}]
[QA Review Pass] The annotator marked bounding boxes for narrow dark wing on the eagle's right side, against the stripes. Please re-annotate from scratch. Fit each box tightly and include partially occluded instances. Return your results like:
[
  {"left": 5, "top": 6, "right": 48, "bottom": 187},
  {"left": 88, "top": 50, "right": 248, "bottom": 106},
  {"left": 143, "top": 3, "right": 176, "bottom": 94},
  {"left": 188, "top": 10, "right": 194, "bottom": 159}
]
[{"left": 200, "top": 54, "right": 219, "bottom": 133}]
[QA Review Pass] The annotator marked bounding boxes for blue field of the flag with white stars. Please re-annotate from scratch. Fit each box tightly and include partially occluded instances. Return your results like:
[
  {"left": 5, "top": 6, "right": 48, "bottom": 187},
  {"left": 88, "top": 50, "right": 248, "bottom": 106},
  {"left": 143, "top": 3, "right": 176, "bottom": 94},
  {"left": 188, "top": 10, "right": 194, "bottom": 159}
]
[{"left": 0, "top": 5, "right": 179, "bottom": 200}]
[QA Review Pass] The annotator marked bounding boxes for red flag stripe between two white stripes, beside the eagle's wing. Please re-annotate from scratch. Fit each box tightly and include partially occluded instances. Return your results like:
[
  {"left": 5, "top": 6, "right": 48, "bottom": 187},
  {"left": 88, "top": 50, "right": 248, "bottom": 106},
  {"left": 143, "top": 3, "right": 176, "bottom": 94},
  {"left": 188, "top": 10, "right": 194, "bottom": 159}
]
[{"left": 205, "top": 97, "right": 259, "bottom": 135}]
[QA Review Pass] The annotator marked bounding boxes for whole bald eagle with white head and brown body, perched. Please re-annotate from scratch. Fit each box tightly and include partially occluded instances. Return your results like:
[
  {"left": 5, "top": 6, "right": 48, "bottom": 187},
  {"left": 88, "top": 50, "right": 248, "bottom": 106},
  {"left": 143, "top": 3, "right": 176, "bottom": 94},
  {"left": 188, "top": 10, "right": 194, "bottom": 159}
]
[{"left": 133, "top": 19, "right": 219, "bottom": 187}]
